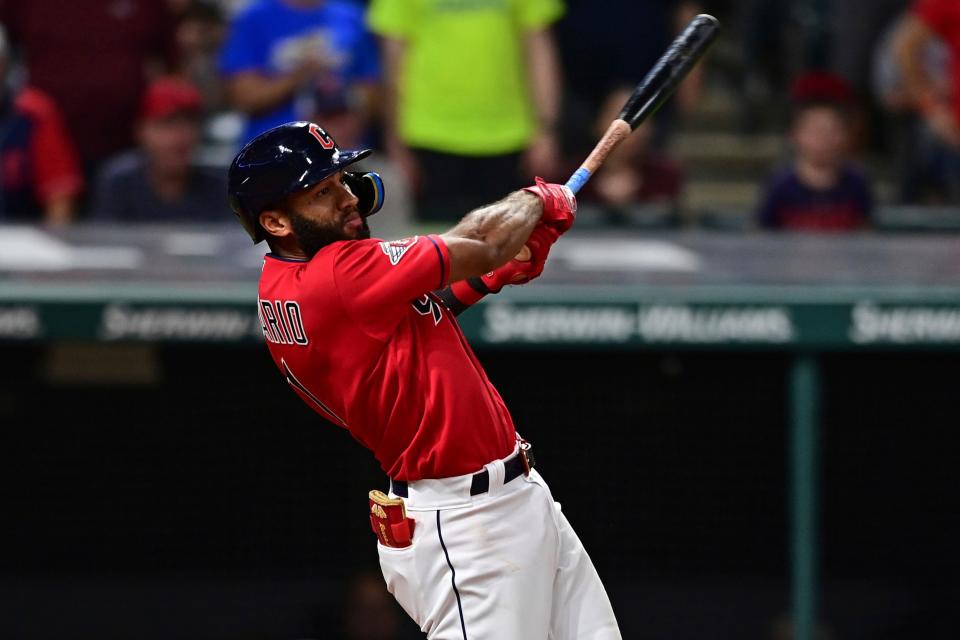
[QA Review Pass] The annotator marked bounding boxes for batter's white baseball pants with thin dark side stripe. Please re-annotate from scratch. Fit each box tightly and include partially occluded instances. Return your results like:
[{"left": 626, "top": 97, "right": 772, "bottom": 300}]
[{"left": 377, "top": 450, "right": 621, "bottom": 640}]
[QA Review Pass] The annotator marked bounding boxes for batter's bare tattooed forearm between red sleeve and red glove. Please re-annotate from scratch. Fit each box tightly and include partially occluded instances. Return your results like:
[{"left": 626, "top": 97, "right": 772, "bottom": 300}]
[{"left": 442, "top": 191, "right": 543, "bottom": 282}]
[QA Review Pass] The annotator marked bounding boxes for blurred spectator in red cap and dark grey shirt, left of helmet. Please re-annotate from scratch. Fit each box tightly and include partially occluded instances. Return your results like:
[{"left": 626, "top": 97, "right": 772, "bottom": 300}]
[{"left": 91, "top": 77, "right": 229, "bottom": 222}]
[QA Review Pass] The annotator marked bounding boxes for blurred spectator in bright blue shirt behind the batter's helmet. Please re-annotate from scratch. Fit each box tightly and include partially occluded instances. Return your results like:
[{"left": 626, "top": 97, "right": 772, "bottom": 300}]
[{"left": 220, "top": 0, "right": 379, "bottom": 147}]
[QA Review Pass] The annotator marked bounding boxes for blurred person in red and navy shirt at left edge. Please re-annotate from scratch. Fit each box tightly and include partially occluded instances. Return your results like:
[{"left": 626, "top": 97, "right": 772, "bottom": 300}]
[{"left": 0, "top": 28, "right": 84, "bottom": 223}]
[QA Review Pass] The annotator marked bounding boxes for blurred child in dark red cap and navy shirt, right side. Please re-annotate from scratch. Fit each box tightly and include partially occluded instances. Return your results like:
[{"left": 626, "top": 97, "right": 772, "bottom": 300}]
[{"left": 757, "top": 71, "right": 873, "bottom": 231}]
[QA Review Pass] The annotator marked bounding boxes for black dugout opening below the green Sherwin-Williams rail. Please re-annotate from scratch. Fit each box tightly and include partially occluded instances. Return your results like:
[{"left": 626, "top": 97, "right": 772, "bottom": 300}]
[{"left": 0, "top": 344, "right": 960, "bottom": 640}]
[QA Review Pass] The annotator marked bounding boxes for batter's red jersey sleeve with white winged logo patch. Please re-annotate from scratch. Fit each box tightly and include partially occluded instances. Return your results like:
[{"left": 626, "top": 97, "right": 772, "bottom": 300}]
[{"left": 333, "top": 235, "right": 450, "bottom": 340}]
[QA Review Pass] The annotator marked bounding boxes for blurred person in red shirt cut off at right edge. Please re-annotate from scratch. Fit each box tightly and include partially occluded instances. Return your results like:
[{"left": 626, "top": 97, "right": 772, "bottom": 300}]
[{"left": 894, "top": 0, "right": 960, "bottom": 203}]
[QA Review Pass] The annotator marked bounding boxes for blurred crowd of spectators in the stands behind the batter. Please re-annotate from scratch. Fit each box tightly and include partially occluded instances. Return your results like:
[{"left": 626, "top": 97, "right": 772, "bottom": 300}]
[{"left": 0, "top": 0, "right": 960, "bottom": 231}]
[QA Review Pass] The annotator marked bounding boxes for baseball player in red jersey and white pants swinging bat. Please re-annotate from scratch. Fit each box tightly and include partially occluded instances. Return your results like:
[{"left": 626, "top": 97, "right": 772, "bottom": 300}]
[{"left": 229, "top": 122, "right": 621, "bottom": 640}]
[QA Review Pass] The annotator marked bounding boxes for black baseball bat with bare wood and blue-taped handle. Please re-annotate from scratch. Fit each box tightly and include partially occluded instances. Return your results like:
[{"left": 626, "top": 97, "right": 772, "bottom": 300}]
[{"left": 517, "top": 13, "right": 720, "bottom": 260}]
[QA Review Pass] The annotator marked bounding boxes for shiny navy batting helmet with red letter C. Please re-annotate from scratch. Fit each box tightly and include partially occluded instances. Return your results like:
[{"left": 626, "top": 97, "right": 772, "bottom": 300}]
[{"left": 228, "top": 122, "right": 383, "bottom": 243}]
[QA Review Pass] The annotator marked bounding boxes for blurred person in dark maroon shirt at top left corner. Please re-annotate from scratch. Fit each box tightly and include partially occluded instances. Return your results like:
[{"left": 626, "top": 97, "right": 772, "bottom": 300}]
[{"left": 0, "top": 0, "right": 176, "bottom": 182}]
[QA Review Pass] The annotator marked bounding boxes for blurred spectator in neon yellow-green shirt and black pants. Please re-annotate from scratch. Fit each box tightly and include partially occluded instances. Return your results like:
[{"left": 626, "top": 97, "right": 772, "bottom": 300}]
[{"left": 367, "top": 0, "right": 564, "bottom": 221}]
